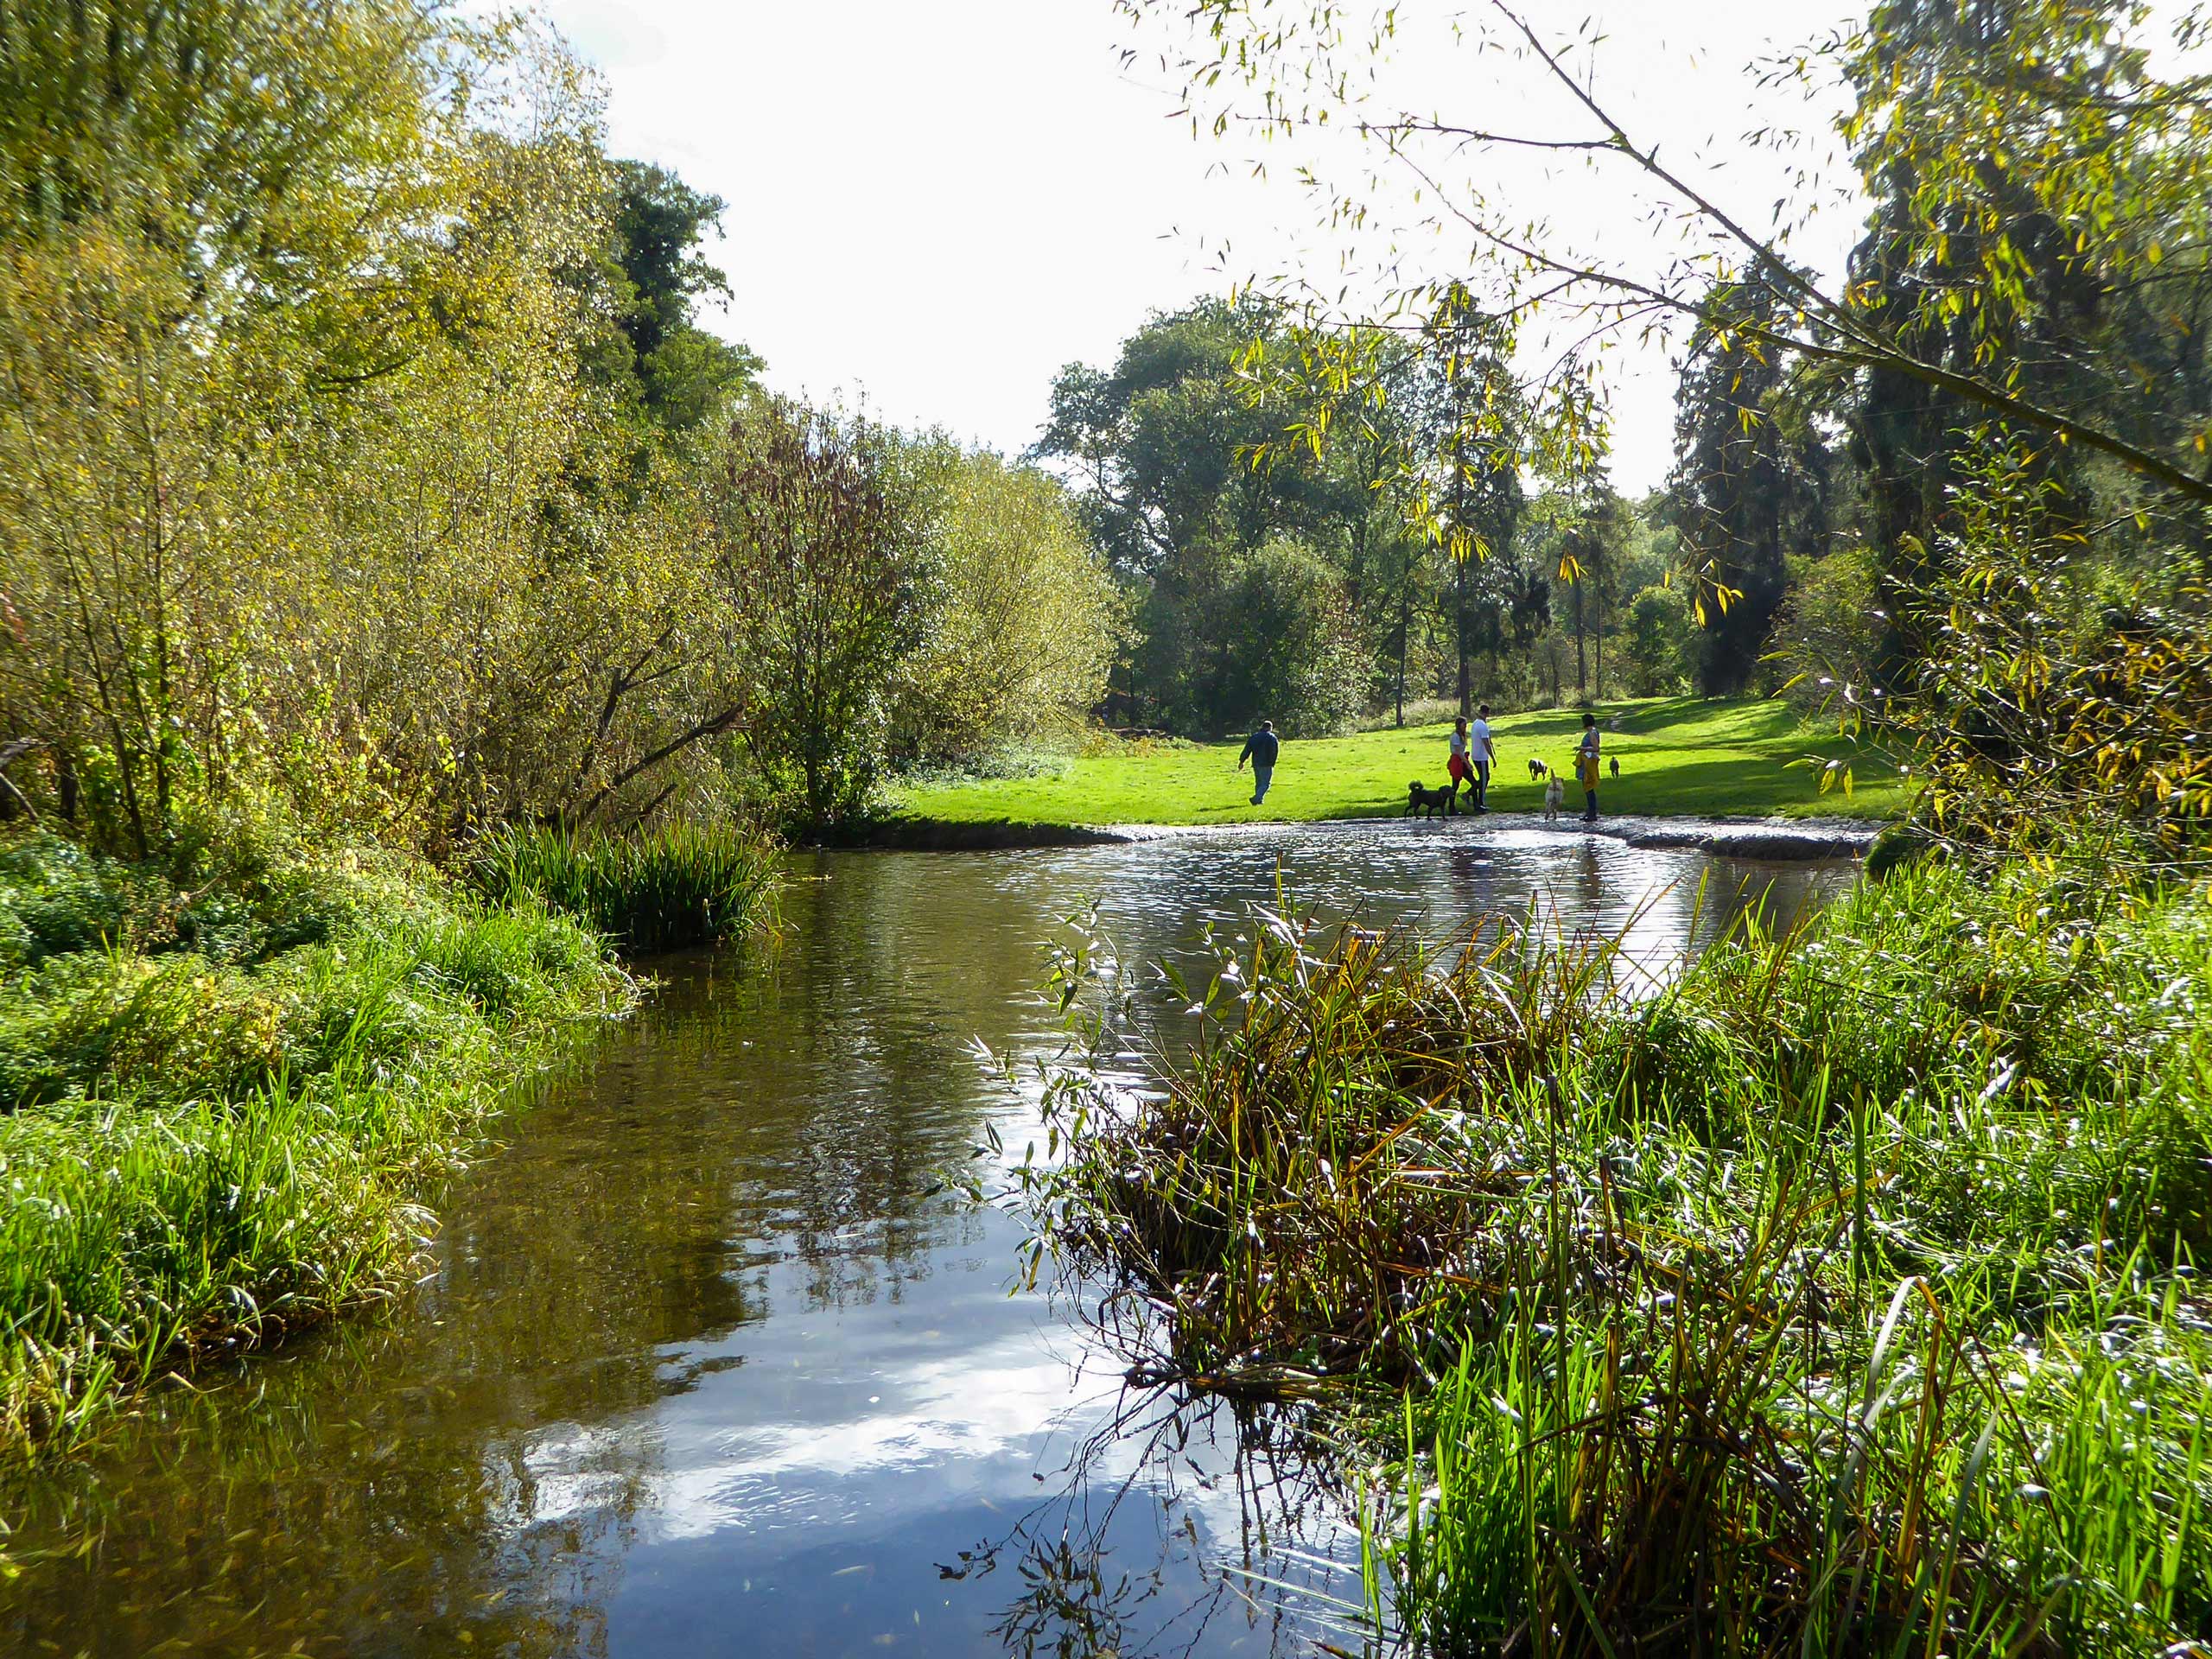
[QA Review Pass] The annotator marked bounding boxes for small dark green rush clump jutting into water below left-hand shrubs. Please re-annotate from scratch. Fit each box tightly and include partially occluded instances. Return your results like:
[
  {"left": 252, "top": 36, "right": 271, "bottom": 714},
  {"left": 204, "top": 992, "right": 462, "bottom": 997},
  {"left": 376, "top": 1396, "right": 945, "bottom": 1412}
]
[{"left": 471, "top": 818, "right": 777, "bottom": 953}]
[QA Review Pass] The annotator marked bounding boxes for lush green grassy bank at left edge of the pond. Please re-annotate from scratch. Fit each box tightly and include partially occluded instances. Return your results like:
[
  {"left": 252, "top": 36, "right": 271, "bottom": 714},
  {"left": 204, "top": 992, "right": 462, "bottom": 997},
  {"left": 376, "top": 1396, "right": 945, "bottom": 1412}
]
[{"left": 0, "top": 845, "right": 637, "bottom": 1455}]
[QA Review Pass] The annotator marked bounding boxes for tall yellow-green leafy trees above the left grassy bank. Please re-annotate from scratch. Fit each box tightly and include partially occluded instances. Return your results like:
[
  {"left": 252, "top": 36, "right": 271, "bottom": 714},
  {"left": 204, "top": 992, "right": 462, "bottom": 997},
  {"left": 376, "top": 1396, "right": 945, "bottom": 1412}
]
[{"left": 0, "top": 0, "right": 765, "bottom": 844}]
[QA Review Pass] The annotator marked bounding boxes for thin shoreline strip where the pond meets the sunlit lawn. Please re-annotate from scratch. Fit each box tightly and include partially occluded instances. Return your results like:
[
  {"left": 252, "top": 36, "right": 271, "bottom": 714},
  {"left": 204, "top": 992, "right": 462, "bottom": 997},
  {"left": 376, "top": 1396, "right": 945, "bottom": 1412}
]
[{"left": 810, "top": 812, "right": 1885, "bottom": 861}]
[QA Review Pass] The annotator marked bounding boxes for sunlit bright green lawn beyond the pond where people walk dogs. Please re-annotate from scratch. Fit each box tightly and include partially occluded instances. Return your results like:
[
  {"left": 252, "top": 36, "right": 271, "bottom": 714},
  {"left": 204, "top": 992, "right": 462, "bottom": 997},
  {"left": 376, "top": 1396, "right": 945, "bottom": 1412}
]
[{"left": 893, "top": 696, "right": 1904, "bottom": 823}]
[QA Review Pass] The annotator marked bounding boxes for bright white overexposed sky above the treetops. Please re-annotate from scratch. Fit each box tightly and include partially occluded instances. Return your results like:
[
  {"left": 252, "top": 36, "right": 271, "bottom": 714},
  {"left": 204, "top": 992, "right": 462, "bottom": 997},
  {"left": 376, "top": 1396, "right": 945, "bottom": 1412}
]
[{"left": 544, "top": 0, "right": 1858, "bottom": 491}]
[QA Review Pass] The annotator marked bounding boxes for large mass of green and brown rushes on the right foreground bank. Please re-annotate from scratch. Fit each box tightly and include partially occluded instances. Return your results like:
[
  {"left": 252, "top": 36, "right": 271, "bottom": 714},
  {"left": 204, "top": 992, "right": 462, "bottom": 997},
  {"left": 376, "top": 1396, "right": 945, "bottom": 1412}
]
[{"left": 1024, "top": 868, "right": 2212, "bottom": 1655}]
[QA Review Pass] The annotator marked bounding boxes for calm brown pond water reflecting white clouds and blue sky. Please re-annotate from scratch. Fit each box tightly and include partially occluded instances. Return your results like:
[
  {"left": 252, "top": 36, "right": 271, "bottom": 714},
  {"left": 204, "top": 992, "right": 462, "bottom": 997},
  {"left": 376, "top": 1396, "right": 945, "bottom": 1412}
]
[{"left": 0, "top": 823, "right": 1852, "bottom": 1659}]
